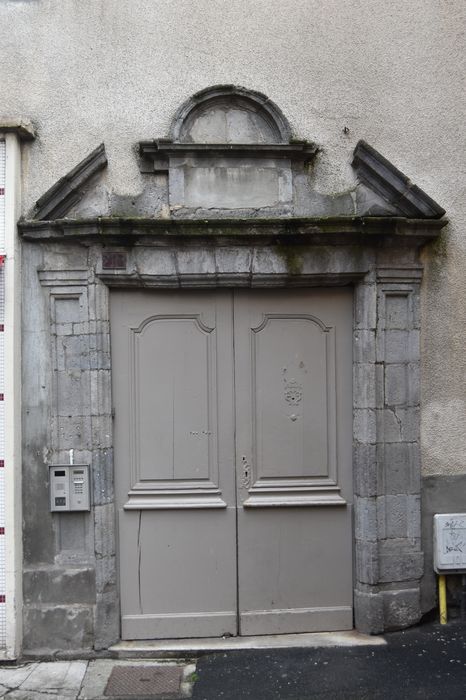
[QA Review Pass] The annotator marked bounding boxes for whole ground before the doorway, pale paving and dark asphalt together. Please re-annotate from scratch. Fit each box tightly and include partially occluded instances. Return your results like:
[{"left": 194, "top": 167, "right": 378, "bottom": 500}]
[{"left": 0, "top": 624, "right": 466, "bottom": 700}]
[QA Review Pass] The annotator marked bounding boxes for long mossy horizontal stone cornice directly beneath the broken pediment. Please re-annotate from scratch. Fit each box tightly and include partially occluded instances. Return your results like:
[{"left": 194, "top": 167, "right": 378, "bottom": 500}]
[{"left": 18, "top": 217, "right": 448, "bottom": 247}]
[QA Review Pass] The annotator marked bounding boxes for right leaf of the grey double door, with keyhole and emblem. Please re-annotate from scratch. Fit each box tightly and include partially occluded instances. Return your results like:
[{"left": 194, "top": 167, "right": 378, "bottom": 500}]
[{"left": 234, "top": 289, "right": 352, "bottom": 634}]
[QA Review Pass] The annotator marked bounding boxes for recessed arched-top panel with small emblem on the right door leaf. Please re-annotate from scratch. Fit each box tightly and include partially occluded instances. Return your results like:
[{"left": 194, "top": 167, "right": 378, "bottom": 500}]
[{"left": 250, "top": 313, "right": 335, "bottom": 479}]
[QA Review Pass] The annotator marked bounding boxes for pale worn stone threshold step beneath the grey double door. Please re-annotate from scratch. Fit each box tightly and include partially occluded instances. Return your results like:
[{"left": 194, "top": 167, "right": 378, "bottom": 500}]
[{"left": 109, "top": 630, "right": 386, "bottom": 659}]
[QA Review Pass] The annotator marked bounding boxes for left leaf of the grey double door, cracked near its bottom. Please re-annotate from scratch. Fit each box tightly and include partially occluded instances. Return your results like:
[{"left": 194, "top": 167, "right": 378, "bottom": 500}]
[{"left": 111, "top": 291, "right": 237, "bottom": 639}]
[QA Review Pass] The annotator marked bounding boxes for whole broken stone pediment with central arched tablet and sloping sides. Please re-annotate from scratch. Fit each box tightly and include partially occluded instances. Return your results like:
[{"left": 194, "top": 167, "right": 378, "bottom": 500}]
[{"left": 28, "top": 86, "right": 445, "bottom": 221}]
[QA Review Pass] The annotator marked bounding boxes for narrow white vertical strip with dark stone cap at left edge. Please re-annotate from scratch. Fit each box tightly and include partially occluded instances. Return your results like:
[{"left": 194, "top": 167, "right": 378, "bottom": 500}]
[{"left": 0, "top": 120, "right": 34, "bottom": 659}]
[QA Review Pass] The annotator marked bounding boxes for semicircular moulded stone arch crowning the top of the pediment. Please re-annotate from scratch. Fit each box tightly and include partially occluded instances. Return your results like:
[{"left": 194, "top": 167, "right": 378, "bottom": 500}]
[{"left": 171, "top": 85, "right": 291, "bottom": 144}]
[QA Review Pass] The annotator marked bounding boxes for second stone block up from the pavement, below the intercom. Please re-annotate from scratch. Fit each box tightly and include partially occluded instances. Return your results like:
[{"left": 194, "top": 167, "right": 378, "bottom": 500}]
[{"left": 23, "top": 567, "right": 95, "bottom": 605}]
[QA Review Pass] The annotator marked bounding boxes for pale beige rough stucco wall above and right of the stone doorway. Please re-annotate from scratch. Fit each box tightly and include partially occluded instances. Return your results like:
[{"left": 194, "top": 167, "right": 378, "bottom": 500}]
[{"left": 0, "top": 0, "right": 466, "bottom": 475}]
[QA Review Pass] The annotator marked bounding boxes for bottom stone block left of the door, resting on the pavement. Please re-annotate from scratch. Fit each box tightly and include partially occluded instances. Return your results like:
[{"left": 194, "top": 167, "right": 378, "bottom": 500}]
[{"left": 23, "top": 605, "right": 94, "bottom": 654}]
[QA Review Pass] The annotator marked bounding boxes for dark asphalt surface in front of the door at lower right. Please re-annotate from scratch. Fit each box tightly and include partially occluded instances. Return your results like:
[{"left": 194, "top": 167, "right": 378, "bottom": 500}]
[{"left": 193, "top": 623, "right": 466, "bottom": 700}]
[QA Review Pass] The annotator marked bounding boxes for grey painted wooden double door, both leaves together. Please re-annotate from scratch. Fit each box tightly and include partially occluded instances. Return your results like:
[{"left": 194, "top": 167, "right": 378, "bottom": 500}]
[{"left": 111, "top": 289, "right": 352, "bottom": 639}]
